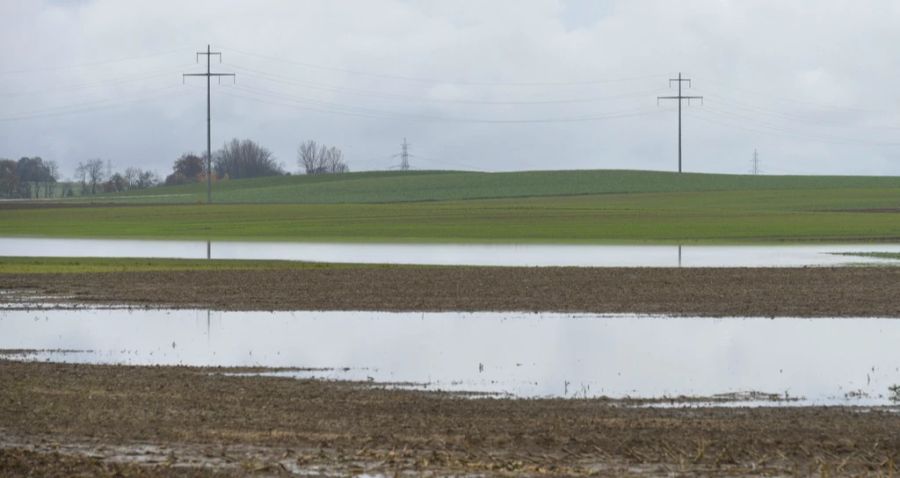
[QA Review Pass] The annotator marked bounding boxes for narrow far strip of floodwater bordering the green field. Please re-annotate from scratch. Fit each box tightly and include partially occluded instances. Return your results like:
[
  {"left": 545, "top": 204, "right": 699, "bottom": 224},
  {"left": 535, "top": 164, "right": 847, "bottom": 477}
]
[{"left": 0, "top": 238, "right": 900, "bottom": 267}]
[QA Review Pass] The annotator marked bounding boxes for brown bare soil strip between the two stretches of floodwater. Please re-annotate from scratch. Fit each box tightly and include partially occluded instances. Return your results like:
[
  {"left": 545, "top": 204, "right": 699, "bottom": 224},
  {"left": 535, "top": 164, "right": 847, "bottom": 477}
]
[{"left": 0, "top": 266, "right": 900, "bottom": 317}]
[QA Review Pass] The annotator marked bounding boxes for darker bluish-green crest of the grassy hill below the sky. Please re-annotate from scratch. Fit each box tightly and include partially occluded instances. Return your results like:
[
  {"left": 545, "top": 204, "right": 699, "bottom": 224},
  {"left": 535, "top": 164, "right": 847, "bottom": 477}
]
[{"left": 78, "top": 170, "right": 900, "bottom": 204}]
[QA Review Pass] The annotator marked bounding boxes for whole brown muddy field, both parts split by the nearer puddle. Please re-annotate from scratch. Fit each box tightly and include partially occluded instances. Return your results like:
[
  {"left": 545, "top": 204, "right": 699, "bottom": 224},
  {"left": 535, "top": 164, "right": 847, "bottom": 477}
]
[{"left": 0, "top": 266, "right": 900, "bottom": 477}]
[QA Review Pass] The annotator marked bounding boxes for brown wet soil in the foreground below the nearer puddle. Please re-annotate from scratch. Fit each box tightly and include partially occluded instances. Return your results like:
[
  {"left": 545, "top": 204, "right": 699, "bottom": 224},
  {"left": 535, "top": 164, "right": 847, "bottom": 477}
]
[{"left": 0, "top": 360, "right": 900, "bottom": 476}]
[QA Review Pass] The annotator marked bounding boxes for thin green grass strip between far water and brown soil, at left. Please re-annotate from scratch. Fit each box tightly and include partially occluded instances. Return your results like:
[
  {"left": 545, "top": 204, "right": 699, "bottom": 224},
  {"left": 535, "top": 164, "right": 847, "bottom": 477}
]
[{"left": 0, "top": 257, "right": 372, "bottom": 274}]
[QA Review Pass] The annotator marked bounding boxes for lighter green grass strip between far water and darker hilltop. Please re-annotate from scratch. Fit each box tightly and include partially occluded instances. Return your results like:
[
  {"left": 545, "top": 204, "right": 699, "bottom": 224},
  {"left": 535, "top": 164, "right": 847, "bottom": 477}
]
[{"left": 0, "top": 187, "right": 900, "bottom": 243}]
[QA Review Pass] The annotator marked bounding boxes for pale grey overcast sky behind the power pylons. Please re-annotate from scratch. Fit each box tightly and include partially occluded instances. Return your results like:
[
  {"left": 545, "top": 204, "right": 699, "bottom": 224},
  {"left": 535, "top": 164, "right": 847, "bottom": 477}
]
[{"left": 0, "top": 0, "right": 900, "bottom": 176}]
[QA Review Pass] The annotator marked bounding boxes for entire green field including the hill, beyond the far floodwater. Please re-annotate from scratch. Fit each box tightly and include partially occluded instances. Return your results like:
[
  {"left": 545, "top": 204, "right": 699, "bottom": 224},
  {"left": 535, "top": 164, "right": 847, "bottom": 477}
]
[{"left": 0, "top": 171, "right": 900, "bottom": 243}]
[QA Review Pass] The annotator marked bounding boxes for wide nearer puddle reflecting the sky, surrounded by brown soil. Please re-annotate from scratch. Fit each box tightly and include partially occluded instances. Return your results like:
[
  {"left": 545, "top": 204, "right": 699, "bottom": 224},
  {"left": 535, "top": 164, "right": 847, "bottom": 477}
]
[{"left": 0, "top": 309, "right": 900, "bottom": 406}]
